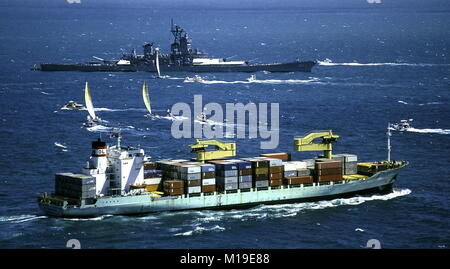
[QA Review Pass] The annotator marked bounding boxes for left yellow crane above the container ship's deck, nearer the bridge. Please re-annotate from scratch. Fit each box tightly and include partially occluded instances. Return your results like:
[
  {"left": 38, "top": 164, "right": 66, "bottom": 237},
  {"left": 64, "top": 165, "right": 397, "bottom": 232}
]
[{"left": 189, "top": 139, "right": 236, "bottom": 162}]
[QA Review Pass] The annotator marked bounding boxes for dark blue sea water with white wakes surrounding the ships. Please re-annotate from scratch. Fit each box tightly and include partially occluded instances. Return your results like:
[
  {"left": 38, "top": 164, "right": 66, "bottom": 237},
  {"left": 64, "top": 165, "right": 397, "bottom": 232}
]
[{"left": 0, "top": 5, "right": 450, "bottom": 248}]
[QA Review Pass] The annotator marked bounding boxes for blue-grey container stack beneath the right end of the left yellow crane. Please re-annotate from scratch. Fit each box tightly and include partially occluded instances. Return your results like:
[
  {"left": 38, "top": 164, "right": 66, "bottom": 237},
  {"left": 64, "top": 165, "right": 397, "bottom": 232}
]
[{"left": 215, "top": 161, "right": 238, "bottom": 191}]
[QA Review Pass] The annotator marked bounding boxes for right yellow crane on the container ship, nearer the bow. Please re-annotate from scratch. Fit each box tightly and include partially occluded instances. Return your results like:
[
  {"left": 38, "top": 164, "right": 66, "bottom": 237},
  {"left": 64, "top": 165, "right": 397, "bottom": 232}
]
[{"left": 294, "top": 130, "right": 339, "bottom": 159}]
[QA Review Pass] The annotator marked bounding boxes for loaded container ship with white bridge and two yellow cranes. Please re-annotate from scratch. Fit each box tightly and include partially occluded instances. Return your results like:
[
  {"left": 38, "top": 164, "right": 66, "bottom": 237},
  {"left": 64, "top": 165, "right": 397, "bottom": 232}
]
[{"left": 38, "top": 130, "right": 408, "bottom": 218}]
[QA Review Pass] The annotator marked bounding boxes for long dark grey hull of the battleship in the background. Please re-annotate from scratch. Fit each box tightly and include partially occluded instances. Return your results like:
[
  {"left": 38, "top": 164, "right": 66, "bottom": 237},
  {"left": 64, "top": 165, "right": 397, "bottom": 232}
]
[{"left": 39, "top": 61, "right": 316, "bottom": 73}]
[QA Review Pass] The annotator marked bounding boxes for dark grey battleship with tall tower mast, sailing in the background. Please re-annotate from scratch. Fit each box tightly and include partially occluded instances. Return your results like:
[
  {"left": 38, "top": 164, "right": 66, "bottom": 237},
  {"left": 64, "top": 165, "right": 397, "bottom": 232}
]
[{"left": 32, "top": 22, "right": 316, "bottom": 75}]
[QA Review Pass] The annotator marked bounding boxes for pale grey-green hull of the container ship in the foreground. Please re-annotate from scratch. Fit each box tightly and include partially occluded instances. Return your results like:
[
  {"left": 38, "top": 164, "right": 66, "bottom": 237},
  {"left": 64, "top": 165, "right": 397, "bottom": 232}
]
[{"left": 39, "top": 168, "right": 400, "bottom": 217}]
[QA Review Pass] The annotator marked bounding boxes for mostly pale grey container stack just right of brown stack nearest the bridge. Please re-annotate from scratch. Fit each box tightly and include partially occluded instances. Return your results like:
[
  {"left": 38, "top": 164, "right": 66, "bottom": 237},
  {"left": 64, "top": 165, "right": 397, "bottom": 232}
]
[{"left": 177, "top": 163, "right": 202, "bottom": 194}]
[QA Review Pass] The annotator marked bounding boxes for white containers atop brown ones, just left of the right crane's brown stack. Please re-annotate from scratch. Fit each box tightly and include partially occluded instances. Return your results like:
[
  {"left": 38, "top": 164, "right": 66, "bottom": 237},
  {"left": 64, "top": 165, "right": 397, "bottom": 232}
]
[{"left": 283, "top": 161, "right": 313, "bottom": 185}]
